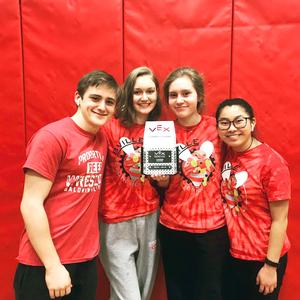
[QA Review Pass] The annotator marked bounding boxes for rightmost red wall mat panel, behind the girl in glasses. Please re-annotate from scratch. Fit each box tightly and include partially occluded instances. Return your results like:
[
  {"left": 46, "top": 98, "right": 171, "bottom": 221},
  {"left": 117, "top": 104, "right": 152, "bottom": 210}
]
[{"left": 232, "top": 0, "right": 300, "bottom": 300}]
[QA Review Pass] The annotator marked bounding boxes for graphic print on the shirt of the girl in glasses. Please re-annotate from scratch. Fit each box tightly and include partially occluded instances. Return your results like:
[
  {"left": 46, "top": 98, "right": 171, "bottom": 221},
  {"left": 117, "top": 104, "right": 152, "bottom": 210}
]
[{"left": 221, "top": 161, "right": 248, "bottom": 212}]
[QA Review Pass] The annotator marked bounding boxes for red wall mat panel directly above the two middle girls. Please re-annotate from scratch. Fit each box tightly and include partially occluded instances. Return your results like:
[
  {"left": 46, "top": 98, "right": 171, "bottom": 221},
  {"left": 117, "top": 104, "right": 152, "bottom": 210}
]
[{"left": 124, "top": 0, "right": 232, "bottom": 120}]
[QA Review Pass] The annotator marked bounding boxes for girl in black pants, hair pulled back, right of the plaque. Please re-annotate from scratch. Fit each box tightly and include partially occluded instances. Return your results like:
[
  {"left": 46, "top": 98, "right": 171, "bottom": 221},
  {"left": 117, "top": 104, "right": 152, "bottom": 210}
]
[{"left": 159, "top": 67, "right": 229, "bottom": 300}]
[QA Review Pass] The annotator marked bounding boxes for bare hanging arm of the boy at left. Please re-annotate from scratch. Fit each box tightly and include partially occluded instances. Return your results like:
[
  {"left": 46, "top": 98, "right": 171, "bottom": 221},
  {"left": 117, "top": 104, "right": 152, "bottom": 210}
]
[{"left": 21, "top": 170, "right": 72, "bottom": 299}]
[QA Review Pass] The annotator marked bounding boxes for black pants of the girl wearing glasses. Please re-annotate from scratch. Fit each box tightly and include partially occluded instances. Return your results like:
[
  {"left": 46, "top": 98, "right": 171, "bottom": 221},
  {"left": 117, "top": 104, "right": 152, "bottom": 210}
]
[{"left": 226, "top": 254, "right": 287, "bottom": 300}]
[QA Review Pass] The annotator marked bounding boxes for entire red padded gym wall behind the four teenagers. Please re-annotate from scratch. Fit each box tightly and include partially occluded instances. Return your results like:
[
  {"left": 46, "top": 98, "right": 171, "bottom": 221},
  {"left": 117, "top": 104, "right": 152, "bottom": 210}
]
[{"left": 0, "top": 0, "right": 300, "bottom": 300}]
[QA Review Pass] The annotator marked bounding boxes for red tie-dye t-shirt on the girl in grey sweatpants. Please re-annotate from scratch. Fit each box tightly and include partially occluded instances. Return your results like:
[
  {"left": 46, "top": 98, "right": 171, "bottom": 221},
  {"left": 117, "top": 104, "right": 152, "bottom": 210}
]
[{"left": 100, "top": 119, "right": 159, "bottom": 223}]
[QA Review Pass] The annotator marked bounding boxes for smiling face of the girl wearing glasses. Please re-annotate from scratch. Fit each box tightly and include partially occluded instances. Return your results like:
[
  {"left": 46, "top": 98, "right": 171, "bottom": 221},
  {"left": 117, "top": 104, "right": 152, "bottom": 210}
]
[{"left": 217, "top": 105, "right": 255, "bottom": 152}]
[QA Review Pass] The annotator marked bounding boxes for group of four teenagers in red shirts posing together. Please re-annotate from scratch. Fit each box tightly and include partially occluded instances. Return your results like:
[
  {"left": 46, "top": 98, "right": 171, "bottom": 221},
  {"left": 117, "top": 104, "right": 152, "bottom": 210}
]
[{"left": 14, "top": 67, "right": 291, "bottom": 300}]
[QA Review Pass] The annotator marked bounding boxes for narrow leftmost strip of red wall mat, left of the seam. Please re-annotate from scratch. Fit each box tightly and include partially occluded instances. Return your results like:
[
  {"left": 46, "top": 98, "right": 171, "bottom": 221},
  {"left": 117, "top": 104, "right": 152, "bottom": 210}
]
[{"left": 0, "top": 1, "right": 25, "bottom": 299}]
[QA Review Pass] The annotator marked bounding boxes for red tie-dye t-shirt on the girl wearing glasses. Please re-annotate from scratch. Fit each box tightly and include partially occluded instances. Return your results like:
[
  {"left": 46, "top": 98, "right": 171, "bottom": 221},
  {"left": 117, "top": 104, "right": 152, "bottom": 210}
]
[{"left": 221, "top": 144, "right": 291, "bottom": 260}]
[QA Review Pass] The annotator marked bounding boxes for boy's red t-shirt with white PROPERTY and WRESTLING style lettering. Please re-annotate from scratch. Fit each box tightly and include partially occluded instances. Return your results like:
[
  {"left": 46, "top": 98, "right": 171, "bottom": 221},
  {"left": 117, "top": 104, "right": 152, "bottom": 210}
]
[{"left": 18, "top": 118, "right": 107, "bottom": 266}]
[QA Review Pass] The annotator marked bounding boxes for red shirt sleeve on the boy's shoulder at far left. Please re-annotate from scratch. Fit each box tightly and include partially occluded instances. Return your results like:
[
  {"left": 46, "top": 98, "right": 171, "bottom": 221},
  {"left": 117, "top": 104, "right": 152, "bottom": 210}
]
[{"left": 23, "top": 129, "right": 63, "bottom": 182}]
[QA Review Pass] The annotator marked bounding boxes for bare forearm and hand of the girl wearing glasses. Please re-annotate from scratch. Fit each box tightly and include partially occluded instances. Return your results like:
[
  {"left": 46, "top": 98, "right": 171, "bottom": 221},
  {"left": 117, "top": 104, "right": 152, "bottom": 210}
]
[{"left": 256, "top": 200, "right": 289, "bottom": 295}]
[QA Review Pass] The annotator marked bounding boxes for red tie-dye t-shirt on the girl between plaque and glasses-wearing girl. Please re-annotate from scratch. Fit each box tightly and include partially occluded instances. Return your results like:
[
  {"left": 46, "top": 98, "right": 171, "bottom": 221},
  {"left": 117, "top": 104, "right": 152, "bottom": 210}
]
[{"left": 160, "top": 116, "right": 225, "bottom": 233}]
